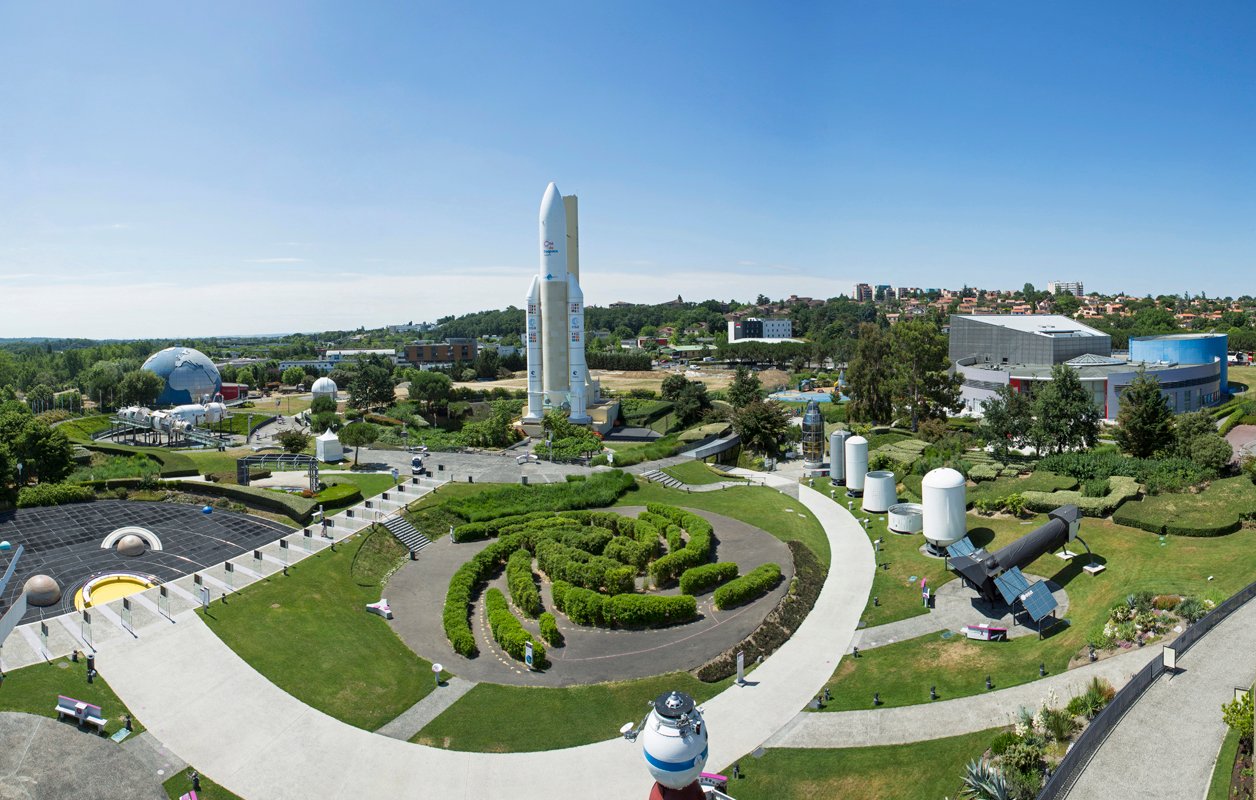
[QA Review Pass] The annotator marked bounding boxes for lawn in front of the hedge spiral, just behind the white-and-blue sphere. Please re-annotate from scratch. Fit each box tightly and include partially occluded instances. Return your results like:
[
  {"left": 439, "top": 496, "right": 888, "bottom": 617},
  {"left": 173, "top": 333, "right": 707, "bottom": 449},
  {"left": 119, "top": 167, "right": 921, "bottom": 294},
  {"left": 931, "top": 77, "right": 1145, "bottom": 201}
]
[{"left": 411, "top": 672, "right": 732, "bottom": 752}]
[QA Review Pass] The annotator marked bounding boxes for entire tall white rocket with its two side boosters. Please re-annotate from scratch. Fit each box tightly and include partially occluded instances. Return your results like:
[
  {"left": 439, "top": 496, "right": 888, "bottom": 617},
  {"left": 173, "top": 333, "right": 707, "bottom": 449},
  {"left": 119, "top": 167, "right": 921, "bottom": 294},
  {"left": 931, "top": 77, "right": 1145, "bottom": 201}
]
[{"left": 524, "top": 183, "right": 590, "bottom": 424}]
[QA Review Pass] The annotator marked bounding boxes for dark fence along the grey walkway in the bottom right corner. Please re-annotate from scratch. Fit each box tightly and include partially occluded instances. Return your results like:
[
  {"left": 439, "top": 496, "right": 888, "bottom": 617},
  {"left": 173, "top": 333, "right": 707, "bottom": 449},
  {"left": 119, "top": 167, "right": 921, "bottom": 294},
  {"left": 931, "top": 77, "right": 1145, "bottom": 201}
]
[{"left": 1037, "top": 583, "right": 1256, "bottom": 800}]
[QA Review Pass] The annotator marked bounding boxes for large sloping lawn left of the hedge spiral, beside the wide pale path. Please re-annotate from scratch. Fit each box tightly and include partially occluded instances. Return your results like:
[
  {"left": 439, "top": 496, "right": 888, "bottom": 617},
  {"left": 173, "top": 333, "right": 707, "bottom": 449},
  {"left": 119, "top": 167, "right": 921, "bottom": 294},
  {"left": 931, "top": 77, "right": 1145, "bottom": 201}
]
[{"left": 201, "top": 529, "right": 438, "bottom": 731}]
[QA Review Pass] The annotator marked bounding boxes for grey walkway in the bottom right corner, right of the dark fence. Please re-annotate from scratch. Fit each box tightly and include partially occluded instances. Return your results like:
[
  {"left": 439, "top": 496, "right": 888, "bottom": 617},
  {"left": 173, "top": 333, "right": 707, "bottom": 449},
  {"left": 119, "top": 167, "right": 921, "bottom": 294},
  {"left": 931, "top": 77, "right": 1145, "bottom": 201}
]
[{"left": 1069, "top": 603, "right": 1256, "bottom": 800}]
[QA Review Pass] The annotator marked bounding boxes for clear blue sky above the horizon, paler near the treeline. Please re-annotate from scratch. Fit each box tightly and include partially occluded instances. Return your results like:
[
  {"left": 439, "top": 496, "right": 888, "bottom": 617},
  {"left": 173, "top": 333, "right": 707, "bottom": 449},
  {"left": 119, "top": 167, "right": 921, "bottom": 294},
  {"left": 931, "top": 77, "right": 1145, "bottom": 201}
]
[{"left": 0, "top": 0, "right": 1256, "bottom": 337}]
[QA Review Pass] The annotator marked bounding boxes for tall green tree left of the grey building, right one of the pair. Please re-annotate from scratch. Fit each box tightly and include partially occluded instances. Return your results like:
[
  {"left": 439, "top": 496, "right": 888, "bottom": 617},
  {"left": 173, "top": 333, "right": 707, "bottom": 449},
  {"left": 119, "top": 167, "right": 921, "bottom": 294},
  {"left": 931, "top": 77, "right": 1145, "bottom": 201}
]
[{"left": 889, "top": 319, "right": 962, "bottom": 431}]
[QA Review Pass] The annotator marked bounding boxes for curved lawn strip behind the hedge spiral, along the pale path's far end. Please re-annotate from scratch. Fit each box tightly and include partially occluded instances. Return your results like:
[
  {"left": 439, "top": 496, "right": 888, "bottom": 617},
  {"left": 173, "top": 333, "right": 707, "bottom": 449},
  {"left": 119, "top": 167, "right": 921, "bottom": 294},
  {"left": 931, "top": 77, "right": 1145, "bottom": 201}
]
[{"left": 612, "top": 482, "right": 830, "bottom": 566}]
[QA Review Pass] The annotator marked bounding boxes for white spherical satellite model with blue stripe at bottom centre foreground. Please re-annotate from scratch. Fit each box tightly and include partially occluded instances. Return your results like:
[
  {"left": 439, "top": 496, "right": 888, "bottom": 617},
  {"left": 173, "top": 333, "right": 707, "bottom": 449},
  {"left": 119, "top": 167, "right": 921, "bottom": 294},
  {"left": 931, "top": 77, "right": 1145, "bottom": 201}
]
[{"left": 641, "top": 692, "right": 708, "bottom": 789}]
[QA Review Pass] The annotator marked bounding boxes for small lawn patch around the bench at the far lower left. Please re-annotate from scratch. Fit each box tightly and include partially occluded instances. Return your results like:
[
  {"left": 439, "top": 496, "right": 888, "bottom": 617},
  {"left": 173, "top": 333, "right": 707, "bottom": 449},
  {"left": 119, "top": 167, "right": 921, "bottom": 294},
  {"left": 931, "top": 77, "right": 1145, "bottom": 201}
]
[{"left": 0, "top": 657, "right": 144, "bottom": 735}]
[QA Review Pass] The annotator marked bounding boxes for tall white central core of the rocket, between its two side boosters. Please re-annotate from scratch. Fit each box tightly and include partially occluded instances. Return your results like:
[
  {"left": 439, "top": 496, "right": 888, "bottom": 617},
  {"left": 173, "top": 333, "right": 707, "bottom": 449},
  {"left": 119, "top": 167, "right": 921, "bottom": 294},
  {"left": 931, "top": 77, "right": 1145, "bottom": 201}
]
[{"left": 539, "top": 183, "right": 583, "bottom": 407}]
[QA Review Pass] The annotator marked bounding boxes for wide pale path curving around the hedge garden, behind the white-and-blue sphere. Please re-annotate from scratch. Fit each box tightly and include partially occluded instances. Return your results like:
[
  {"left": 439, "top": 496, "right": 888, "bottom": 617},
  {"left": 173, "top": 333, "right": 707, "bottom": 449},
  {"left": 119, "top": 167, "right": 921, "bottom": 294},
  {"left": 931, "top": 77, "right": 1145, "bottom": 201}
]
[{"left": 98, "top": 479, "right": 874, "bottom": 800}]
